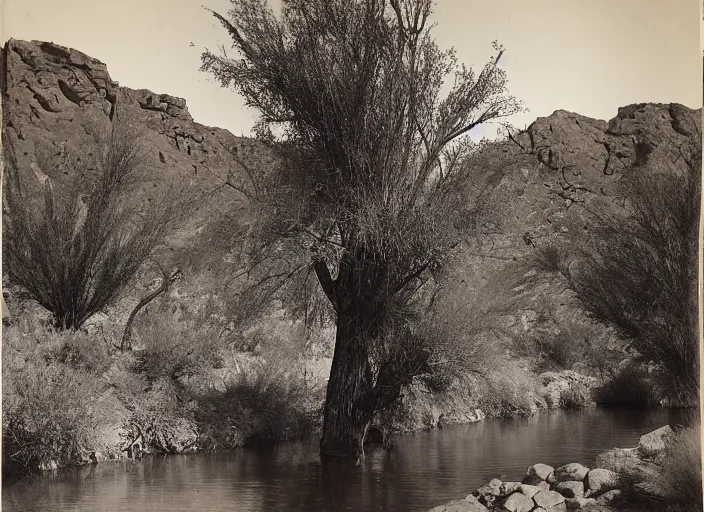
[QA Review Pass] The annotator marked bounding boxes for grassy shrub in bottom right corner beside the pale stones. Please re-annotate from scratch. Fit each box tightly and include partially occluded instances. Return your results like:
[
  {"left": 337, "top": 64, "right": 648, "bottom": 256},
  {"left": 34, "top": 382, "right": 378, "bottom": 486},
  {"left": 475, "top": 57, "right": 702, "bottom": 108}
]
[{"left": 644, "top": 426, "right": 702, "bottom": 512}]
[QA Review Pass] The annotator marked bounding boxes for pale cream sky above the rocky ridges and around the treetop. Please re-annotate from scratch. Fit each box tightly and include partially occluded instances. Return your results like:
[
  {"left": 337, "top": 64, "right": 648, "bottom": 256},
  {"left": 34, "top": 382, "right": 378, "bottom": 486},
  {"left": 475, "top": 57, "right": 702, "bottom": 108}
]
[{"left": 0, "top": 0, "right": 702, "bottom": 135}]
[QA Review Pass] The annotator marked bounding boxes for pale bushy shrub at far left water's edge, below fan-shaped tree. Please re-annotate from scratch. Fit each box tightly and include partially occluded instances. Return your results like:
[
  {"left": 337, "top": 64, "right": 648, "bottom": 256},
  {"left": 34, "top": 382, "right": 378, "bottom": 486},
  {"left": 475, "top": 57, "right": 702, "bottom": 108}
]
[{"left": 2, "top": 329, "right": 112, "bottom": 471}]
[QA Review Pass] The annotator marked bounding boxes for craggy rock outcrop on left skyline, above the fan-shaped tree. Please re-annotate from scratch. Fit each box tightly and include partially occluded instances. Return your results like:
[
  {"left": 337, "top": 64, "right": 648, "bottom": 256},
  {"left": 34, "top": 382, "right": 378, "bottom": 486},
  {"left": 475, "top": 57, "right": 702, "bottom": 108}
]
[{"left": 1, "top": 39, "right": 271, "bottom": 318}]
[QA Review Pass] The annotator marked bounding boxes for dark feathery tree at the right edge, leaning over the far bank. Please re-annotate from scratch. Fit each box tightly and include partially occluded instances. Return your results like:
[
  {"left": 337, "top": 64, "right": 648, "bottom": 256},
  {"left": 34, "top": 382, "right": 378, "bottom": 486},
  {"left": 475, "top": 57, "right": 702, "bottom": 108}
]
[{"left": 540, "top": 139, "right": 701, "bottom": 404}]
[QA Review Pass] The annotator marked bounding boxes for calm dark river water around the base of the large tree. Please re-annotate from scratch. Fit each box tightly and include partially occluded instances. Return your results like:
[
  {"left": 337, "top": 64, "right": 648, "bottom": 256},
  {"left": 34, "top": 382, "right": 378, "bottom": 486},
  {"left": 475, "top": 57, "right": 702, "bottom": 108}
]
[{"left": 2, "top": 408, "right": 680, "bottom": 512}]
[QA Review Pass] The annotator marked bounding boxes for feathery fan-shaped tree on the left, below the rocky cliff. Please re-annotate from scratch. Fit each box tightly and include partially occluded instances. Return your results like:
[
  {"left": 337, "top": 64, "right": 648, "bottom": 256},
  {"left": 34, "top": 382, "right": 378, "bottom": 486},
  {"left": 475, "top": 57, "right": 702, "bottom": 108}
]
[{"left": 3, "top": 123, "right": 184, "bottom": 329}]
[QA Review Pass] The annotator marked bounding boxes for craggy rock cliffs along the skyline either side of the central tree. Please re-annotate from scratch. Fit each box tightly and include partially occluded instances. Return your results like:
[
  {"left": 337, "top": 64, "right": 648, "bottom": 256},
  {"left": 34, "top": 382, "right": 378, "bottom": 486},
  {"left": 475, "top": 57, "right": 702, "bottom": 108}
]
[{"left": 2, "top": 40, "right": 701, "bottom": 336}]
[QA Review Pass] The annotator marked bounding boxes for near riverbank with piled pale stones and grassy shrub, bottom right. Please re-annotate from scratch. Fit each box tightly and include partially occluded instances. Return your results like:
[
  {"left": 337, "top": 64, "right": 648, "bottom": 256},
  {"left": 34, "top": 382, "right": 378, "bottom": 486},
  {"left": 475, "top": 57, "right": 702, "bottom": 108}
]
[{"left": 430, "top": 425, "right": 702, "bottom": 512}]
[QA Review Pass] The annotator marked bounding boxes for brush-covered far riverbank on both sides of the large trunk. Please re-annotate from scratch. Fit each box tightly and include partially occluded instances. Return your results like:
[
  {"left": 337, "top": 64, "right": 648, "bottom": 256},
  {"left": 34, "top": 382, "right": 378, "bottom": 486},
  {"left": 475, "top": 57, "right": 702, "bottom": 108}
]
[{"left": 3, "top": 312, "right": 598, "bottom": 474}]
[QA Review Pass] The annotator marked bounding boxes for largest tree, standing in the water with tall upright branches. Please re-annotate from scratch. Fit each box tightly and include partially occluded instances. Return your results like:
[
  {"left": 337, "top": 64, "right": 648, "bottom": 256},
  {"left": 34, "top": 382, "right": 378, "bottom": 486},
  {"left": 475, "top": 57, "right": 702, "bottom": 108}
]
[{"left": 202, "top": 0, "right": 521, "bottom": 457}]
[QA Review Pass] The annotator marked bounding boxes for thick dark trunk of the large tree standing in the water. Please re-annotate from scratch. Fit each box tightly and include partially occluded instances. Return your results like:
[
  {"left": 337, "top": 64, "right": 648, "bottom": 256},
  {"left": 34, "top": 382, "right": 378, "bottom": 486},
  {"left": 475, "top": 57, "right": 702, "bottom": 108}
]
[{"left": 320, "top": 308, "right": 375, "bottom": 458}]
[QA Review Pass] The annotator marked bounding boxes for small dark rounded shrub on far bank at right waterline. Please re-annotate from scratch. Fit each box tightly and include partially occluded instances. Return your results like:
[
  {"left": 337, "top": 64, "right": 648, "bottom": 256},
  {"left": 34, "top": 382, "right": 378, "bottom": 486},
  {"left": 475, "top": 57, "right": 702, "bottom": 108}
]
[{"left": 594, "top": 363, "right": 657, "bottom": 406}]
